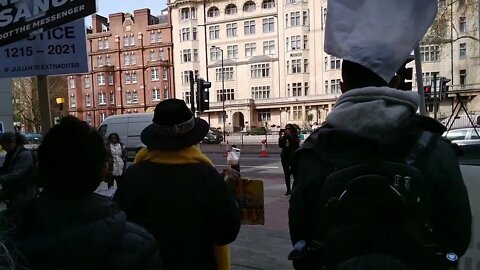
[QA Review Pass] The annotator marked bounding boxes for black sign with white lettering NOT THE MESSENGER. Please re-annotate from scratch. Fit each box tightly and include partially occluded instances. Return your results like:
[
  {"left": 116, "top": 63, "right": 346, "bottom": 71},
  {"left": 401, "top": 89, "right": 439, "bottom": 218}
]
[{"left": 0, "top": 0, "right": 96, "bottom": 46}]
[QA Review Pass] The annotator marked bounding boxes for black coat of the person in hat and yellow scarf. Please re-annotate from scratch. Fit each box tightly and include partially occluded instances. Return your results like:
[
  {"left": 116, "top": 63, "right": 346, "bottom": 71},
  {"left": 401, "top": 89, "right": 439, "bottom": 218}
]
[{"left": 114, "top": 161, "right": 240, "bottom": 270}]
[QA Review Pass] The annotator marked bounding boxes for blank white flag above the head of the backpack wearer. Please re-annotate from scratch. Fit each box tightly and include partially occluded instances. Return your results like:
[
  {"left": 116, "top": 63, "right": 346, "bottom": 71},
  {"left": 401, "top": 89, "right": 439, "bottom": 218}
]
[{"left": 325, "top": 0, "right": 437, "bottom": 82}]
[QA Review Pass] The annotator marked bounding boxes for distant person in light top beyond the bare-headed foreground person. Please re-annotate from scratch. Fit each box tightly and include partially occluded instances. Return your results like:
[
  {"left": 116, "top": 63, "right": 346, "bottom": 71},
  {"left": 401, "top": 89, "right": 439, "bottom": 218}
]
[{"left": 106, "top": 133, "right": 127, "bottom": 189}]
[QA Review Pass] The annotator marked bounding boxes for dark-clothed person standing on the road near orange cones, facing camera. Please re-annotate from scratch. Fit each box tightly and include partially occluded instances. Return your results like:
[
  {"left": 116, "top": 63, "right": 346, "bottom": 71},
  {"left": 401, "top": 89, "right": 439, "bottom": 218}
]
[{"left": 278, "top": 124, "right": 300, "bottom": 196}]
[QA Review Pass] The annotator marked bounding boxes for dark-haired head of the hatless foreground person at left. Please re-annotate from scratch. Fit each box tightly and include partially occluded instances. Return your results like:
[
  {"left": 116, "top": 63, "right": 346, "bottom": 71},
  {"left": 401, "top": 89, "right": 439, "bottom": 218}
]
[{"left": 38, "top": 116, "right": 107, "bottom": 196}]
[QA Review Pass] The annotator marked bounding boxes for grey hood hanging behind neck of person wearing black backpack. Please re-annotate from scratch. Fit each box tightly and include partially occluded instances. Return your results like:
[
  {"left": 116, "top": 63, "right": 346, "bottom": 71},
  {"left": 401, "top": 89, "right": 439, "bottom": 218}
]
[{"left": 326, "top": 87, "right": 420, "bottom": 144}]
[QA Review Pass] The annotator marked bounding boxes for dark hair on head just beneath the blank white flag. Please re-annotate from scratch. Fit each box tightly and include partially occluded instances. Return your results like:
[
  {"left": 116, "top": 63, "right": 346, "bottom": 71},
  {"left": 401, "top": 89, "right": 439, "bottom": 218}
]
[{"left": 342, "top": 60, "right": 388, "bottom": 91}]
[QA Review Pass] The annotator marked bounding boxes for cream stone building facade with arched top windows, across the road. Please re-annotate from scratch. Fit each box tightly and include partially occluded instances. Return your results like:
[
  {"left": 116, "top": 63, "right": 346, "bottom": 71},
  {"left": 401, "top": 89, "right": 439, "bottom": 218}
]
[{"left": 168, "top": 0, "right": 480, "bottom": 131}]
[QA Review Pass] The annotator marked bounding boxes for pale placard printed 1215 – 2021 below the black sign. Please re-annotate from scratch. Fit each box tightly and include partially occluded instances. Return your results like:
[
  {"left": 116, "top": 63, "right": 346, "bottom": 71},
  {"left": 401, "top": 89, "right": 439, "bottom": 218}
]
[{"left": 0, "top": 18, "right": 88, "bottom": 78}]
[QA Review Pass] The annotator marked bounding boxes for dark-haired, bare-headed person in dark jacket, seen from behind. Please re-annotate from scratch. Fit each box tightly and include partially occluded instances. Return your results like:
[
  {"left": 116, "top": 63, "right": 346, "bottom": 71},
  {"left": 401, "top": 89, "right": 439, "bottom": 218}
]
[{"left": 14, "top": 116, "right": 164, "bottom": 270}]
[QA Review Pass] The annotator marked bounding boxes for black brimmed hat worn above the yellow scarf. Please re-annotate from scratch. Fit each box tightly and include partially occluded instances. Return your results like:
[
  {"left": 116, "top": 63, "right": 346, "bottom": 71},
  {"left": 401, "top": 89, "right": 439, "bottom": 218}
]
[{"left": 140, "top": 99, "right": 209, "bottom": 151}]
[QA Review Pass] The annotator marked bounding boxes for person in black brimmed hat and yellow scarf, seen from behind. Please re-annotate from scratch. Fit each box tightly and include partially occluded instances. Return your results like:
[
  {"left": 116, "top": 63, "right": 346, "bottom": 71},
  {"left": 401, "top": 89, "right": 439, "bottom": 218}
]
[{"left": 114, "top": 99, "right": 240, "bottom": 270}]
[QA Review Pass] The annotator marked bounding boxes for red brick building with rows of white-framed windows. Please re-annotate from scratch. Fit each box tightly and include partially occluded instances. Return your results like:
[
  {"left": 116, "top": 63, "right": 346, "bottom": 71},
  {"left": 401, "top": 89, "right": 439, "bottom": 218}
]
[{"left": 66, "top": 9, "right": 175, "bottom": 126}]
